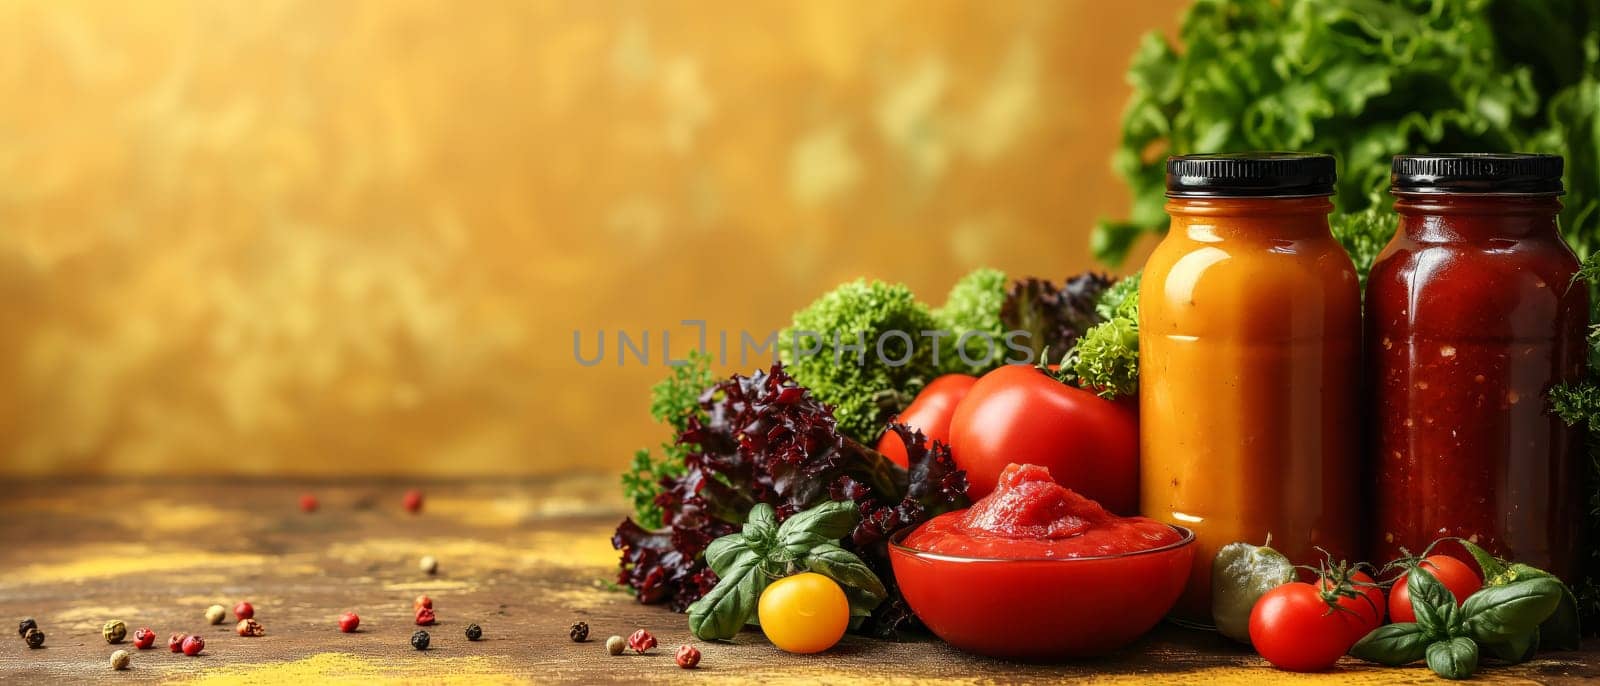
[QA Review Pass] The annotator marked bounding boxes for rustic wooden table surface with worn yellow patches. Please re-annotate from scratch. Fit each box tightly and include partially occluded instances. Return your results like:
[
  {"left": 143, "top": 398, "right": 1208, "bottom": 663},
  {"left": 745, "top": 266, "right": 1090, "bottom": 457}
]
[{"left": 0, "top": 477, "right": 1600, "bottom": 684}]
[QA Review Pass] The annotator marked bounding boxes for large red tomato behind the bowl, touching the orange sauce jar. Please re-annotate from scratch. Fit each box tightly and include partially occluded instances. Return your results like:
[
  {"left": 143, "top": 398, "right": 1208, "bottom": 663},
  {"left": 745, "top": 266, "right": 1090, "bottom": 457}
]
[{"left": 950, "top": 365, "right": 1139, "bottom": 515}]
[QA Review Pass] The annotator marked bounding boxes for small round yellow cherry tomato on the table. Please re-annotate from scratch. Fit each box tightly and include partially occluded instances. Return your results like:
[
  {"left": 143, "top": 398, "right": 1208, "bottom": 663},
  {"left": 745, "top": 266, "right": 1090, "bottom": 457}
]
[{"left": 755, "top": 572, "right": 850, "bottom": 654}]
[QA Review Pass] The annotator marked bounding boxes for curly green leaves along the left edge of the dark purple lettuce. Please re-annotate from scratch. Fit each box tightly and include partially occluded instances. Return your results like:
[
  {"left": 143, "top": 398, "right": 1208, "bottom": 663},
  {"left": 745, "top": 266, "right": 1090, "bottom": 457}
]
[{"left": 622, "top": 350, "right": 715, "bottom": 529}]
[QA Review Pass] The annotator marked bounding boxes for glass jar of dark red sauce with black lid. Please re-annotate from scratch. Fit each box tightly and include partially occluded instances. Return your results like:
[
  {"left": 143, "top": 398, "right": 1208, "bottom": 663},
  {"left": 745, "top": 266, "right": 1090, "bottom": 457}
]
[{"left": 1366, "top": 155, "right": 1589, "bottom": 580}]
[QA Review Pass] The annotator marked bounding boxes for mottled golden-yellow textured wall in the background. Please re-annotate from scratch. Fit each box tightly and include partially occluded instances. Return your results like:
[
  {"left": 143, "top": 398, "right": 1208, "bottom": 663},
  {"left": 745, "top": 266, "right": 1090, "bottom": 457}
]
[{"left": 0, "top": 0, "right": 1181, "bottom": 475}]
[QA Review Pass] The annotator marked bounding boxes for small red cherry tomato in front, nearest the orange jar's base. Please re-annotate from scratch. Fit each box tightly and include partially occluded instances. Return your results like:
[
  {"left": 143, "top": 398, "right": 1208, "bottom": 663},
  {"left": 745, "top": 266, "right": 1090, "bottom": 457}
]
[{"left": 1250, "top": 582, "right": 1365, "bottom": 672}]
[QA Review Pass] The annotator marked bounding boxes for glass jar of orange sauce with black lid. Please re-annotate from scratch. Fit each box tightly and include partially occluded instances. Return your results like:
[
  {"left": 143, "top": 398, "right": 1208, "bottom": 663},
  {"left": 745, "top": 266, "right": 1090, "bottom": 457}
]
[{"left": 1139, "top": 154, "right": 1362, "bottom": 625}]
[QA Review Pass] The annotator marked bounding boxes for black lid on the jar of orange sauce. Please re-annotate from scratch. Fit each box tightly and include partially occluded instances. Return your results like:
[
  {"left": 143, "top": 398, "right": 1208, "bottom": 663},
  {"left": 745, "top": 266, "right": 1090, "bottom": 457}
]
[{"left": 1166, "top": 152, "right": 1338, "bottom": 198}]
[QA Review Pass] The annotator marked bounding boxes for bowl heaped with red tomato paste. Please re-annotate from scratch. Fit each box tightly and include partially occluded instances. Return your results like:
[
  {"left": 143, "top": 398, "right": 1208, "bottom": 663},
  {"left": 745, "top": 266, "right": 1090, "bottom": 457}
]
[{"left": 890, "top": 464, "right": 1194, "bottom": 660}]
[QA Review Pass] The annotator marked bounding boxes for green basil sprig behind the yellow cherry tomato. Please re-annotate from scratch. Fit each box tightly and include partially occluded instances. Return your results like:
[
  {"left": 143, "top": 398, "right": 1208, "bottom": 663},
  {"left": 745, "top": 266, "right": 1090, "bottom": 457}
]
[{"left": 690, "top": 501, "right": 888, "bottom": 641}]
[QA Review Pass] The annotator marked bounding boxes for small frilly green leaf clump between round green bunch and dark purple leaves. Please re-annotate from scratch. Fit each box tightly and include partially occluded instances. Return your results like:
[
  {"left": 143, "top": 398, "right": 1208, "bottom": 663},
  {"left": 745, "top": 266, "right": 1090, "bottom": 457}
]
[{"left": 933, "top": 269, "right": 1008, "bottom": 374}]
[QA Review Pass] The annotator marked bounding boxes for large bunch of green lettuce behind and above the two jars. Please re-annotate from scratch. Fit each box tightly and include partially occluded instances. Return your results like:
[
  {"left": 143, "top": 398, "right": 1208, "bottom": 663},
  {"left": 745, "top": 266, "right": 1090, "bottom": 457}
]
[{"left": 1090, "top": 0, "right": 1600, "bottom": 283}]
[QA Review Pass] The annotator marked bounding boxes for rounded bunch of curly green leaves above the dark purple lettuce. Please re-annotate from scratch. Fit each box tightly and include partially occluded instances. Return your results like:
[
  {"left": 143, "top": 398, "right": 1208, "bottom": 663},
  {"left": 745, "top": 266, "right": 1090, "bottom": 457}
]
[{"left": 778, "top": 280, "right": 955, "bottom": 445}]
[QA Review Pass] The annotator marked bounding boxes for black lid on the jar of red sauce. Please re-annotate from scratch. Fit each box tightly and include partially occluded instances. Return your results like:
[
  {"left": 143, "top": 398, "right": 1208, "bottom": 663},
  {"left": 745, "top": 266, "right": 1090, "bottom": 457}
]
[{"left": 1389, "top": 152, "right": 1565, "bottom": 195}]
